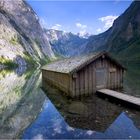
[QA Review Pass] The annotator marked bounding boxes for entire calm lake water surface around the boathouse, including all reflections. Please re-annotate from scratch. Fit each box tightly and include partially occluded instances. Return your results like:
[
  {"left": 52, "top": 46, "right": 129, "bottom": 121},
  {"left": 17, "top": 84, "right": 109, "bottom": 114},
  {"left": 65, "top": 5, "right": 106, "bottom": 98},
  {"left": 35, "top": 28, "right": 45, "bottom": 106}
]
[{"left": 0, "top": 68, "right": 140, "bottom": 139}]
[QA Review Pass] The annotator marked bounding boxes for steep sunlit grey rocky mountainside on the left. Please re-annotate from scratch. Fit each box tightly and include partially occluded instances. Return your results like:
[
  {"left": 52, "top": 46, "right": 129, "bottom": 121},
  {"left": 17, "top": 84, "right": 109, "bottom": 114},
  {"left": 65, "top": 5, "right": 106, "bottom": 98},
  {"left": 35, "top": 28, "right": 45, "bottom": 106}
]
[{"left": 0, "top": 0, "right": 55, "bottom": 68}]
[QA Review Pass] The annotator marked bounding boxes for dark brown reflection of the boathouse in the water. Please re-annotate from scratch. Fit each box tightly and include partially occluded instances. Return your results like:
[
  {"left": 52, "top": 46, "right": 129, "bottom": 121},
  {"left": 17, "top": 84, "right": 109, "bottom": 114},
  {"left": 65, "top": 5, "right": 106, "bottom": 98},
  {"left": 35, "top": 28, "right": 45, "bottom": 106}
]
[{"left": 41, "top": 83, "right": 122, "bottom": 132}]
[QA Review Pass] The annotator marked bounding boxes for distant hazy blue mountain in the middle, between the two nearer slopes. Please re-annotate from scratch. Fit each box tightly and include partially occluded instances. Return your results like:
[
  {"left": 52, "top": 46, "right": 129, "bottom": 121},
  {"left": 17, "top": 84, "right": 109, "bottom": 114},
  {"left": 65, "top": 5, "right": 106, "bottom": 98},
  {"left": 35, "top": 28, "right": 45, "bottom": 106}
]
[{"left": 44, "top": 29, "right": 87, "bottom": 57}]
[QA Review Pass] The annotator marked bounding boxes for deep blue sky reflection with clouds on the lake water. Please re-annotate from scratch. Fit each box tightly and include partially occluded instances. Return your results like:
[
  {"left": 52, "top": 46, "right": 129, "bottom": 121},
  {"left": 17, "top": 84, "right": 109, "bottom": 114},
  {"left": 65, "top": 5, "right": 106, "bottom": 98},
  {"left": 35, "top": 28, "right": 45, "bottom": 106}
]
[{"left": 22, "top": 96, "right": 140, "bottom": 139}]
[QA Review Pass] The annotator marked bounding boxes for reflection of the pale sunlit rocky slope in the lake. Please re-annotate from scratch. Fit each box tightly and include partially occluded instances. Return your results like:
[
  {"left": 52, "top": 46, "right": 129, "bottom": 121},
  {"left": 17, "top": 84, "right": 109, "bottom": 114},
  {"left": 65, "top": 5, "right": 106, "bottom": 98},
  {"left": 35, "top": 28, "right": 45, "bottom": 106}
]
[{"left": 0, "top": 68, "right": 45, "bottom": 139}]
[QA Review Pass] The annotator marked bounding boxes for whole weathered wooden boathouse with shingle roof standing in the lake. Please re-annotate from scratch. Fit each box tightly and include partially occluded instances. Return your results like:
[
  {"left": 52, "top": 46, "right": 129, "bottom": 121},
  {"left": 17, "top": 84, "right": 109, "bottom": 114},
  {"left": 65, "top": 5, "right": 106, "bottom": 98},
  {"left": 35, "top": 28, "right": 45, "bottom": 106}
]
[{"left": 42, "top": 52, "right": 125, "bottom": 97}]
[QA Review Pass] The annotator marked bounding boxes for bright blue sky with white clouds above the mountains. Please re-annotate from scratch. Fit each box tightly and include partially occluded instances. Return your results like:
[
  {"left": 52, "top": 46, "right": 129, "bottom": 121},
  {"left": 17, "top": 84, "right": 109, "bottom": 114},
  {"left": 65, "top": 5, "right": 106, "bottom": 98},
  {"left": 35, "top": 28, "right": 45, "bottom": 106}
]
[{"left": 27, "top": 0, "right": 132, "bottom": 35}]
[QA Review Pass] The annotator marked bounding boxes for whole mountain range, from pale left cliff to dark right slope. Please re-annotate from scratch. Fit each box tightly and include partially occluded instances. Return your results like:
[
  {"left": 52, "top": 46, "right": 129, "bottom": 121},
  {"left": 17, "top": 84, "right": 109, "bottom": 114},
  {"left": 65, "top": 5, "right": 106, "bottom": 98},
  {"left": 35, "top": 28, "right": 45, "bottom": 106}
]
[{"left": 0, "top": 0, "right": 140, "bottom": 67}]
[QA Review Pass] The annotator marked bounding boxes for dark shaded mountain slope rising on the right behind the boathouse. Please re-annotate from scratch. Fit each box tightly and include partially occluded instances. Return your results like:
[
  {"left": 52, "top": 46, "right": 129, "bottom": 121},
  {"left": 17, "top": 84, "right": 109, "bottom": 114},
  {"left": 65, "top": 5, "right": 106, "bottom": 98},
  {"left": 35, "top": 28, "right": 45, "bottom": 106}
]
[{"left": 85, "top": 1, "right": 140, "bottom": 68}]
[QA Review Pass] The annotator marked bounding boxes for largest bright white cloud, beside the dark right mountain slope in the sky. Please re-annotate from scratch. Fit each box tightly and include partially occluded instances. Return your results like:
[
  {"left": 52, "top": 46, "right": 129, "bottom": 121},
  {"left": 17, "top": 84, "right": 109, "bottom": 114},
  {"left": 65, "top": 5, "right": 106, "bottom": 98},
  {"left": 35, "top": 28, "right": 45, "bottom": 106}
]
[{"left": 99, "top": 15, "right": 118, "bottom": 29}]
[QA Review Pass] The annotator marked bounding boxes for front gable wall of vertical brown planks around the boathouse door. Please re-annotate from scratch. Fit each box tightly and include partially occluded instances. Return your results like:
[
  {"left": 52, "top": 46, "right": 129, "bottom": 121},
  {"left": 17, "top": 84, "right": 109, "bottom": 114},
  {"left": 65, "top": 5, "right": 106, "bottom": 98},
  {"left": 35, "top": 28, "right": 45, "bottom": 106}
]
[{"left": 72, "top": 55, "right": 123, "bottom": 96}]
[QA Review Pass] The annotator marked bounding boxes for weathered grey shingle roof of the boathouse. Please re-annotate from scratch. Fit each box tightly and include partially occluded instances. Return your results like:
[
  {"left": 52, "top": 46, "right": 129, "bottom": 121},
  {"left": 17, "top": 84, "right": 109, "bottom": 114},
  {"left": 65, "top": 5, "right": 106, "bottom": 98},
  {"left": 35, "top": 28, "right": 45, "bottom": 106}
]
[{"left": 42, "top": 52, "right": 123, "bottom": 73}]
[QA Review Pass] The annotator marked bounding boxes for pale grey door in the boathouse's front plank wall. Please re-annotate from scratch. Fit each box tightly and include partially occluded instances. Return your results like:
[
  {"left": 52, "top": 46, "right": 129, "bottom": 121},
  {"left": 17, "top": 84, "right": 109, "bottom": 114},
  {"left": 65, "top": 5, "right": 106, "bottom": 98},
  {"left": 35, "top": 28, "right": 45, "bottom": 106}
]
[{"left": 95, "top": 68, "right": 107, "bottom": 89}]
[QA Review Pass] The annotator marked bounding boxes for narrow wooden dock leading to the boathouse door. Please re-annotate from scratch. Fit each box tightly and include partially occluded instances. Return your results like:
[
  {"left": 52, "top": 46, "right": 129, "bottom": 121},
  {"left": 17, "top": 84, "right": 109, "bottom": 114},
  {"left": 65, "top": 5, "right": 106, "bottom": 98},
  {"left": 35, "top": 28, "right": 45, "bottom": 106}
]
[{"left": 97, "top": 89, "right": 140, "bottom": 108}]
